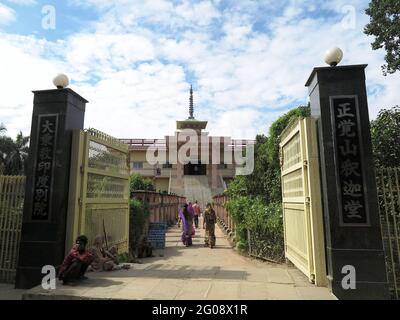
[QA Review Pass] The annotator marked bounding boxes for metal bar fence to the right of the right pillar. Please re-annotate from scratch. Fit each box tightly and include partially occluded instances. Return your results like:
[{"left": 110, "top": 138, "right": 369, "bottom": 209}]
[{"left": 376, "top": 168, "right": 400, "bottom": 299}]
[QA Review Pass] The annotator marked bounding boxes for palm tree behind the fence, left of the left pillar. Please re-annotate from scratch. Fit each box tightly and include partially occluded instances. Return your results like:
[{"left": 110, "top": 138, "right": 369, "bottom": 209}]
[{"left": 5, "top": 131, "right": 29, "bottom": 175}]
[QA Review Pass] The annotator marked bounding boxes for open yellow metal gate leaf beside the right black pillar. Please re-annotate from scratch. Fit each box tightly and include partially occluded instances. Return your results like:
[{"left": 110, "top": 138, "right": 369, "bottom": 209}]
[{"left": 280, "top": 118, "right": 327, "bottom": 286}]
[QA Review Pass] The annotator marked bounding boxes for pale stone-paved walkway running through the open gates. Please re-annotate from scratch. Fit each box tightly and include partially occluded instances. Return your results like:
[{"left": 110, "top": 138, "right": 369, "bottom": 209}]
[{"left": 23, "top": 227, "right": 335, "bottom": 300}]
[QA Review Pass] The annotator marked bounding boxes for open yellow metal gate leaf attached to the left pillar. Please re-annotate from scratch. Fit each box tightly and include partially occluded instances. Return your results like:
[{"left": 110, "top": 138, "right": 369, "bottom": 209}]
[{"left": 66, "top": 129, "right": 129, "bottom": 253}]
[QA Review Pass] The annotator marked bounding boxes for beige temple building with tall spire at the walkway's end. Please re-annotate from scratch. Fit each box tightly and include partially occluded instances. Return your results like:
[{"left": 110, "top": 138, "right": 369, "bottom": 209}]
[{"left": 121, "top": 87, "right": 254, "bottom": 206}]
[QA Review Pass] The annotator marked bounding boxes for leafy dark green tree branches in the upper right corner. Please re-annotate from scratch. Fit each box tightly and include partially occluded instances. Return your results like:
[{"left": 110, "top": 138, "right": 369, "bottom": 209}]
[{"left": 364, "top": 0, "right": 400, "bottom": 75}]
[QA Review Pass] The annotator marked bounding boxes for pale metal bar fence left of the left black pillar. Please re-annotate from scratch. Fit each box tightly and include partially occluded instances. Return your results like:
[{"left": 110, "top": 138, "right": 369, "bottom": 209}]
[{"left": 0, "top": 176, "right": 25, "bottom": 283}]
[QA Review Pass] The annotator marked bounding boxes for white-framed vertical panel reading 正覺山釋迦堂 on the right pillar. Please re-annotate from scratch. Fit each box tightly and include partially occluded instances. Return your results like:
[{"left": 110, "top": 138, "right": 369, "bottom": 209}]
[{"left": 330, "top": 96, "right": 369, "bottom": 226}]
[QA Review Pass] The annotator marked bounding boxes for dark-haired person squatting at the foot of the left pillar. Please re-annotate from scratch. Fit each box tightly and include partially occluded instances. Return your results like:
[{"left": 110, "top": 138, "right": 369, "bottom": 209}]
[{"left": 58, "top": 235, "right": 94, "bottom": 284}]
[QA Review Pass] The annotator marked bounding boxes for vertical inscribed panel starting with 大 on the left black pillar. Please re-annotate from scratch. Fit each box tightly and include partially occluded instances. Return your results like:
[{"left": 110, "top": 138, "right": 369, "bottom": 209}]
[{"left": 32, "top": 114, "right": 58, "bottom": 221}]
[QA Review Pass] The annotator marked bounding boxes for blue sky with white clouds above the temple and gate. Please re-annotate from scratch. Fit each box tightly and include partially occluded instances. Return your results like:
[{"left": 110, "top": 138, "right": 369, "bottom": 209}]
[{"left": 0, "top": 0, "right": 400, "bottom": 138}]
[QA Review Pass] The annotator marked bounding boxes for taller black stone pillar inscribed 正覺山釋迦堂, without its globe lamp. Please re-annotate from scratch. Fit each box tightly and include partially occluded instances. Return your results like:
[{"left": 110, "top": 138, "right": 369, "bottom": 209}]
[{"left": 306, "top": 65, "right": 389, "bottom": 299}]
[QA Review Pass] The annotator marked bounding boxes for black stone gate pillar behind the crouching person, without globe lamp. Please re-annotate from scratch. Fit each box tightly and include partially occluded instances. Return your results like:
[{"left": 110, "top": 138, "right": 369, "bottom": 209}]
[{"left": 16, "top": 89, "right": 87, "bottom": 289}]
